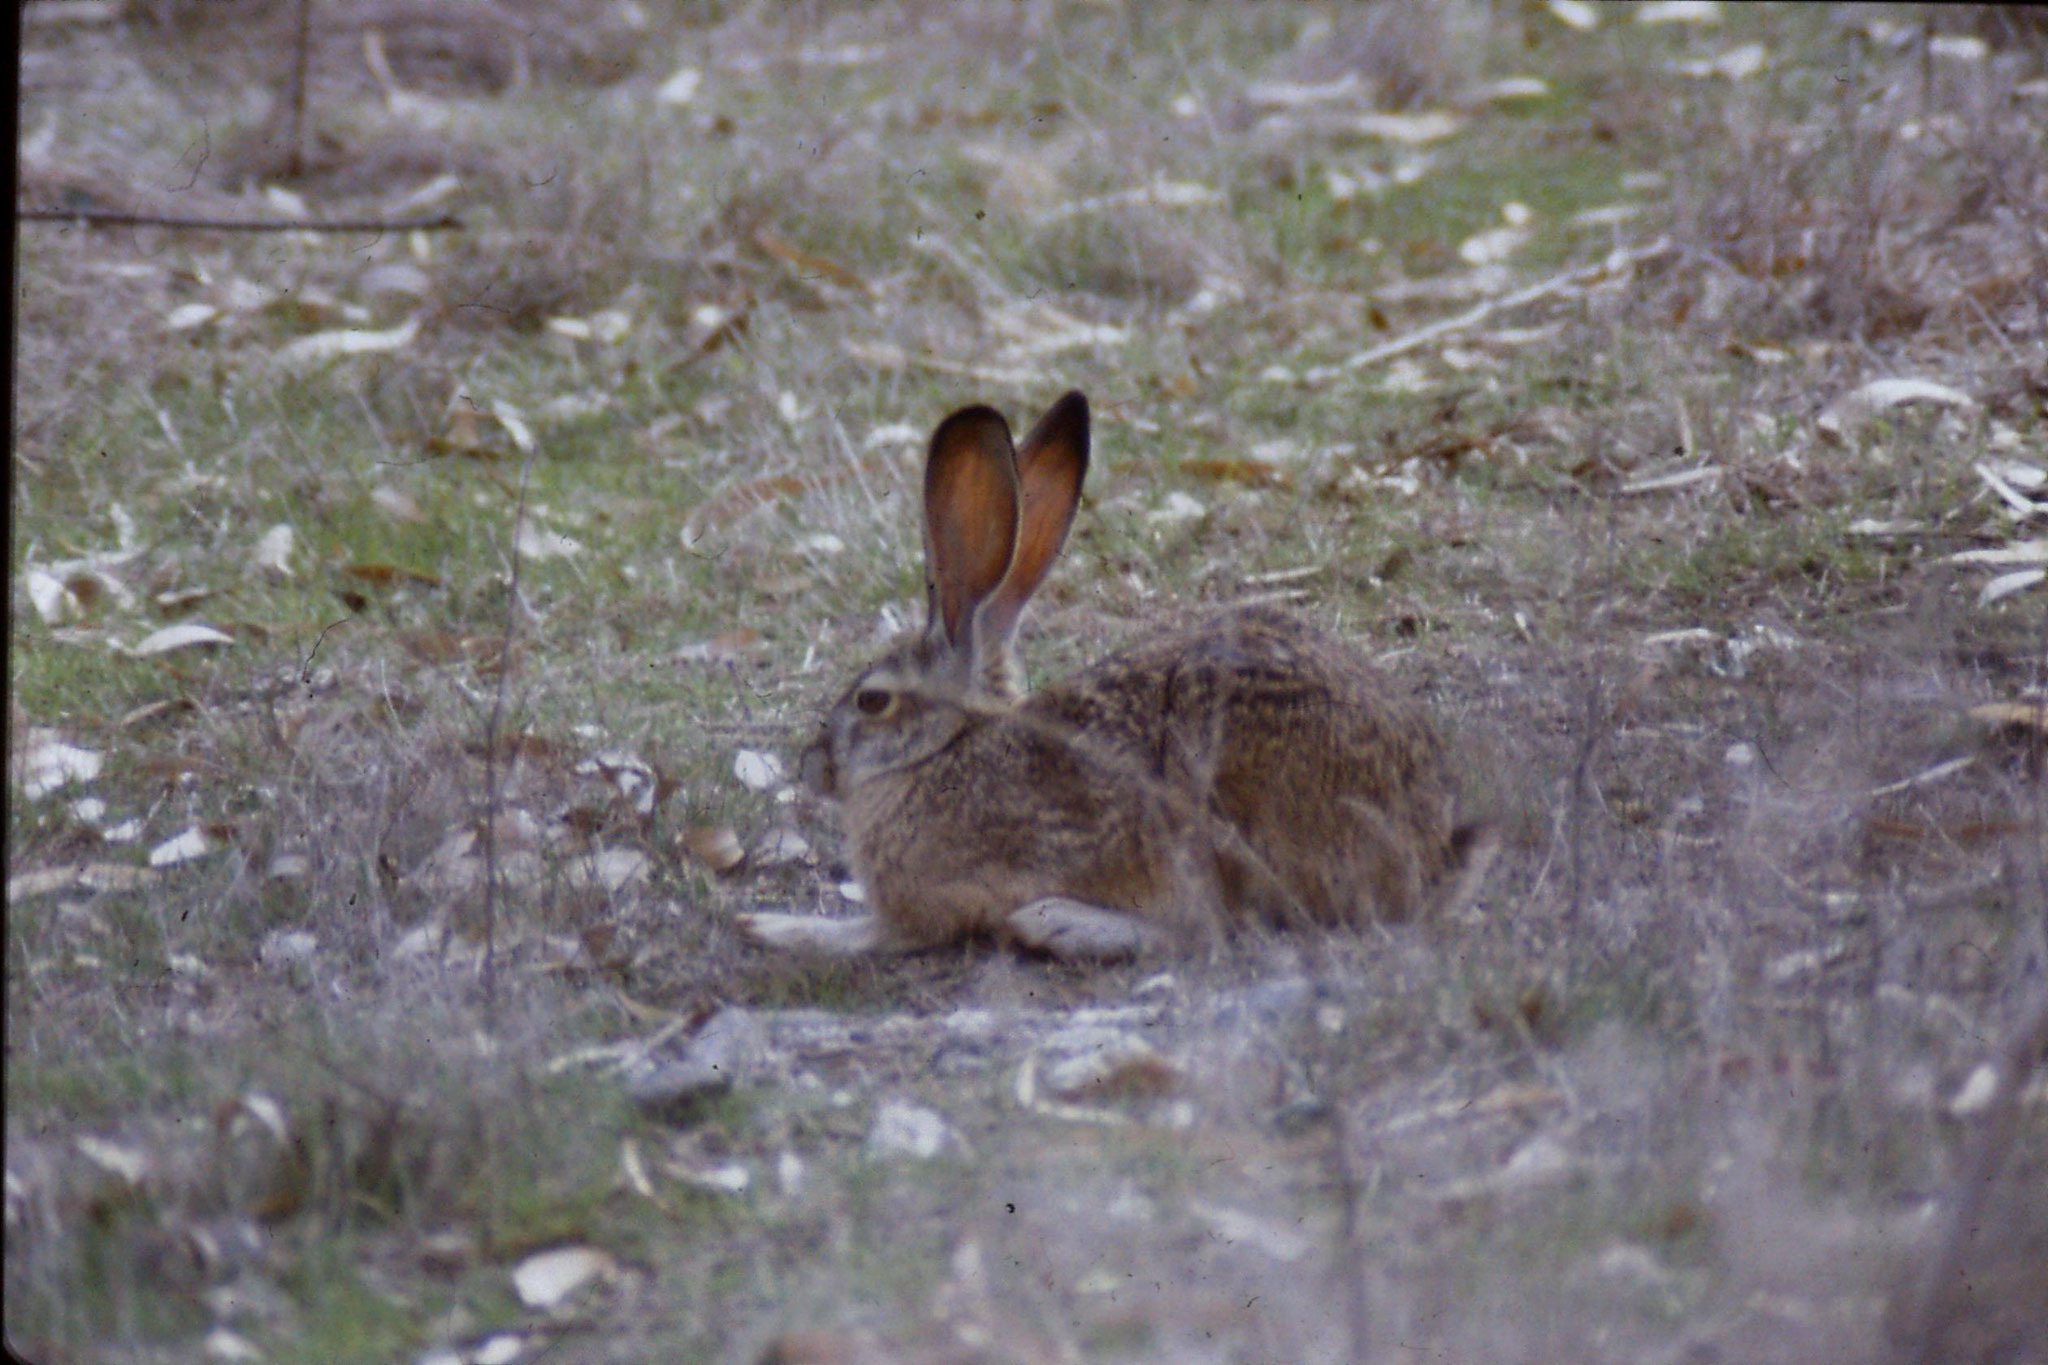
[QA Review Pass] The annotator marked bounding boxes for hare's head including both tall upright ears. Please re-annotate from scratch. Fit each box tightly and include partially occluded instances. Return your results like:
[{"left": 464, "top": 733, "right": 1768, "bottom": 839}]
[{"left": 801, "top": 393, "right": 1087, "bottom": 798}]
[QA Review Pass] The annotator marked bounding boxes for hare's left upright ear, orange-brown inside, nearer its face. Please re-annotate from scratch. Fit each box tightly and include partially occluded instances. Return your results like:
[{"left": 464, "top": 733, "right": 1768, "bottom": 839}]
[{"left": 924, "top": 407, "right": 1018, "bottom": 651}]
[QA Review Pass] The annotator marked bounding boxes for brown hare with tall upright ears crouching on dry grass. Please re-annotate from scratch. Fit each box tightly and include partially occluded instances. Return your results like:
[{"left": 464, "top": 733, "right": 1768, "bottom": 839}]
[{"left": 739, "top": 393, "right": 1483, "bottom": 958}]
